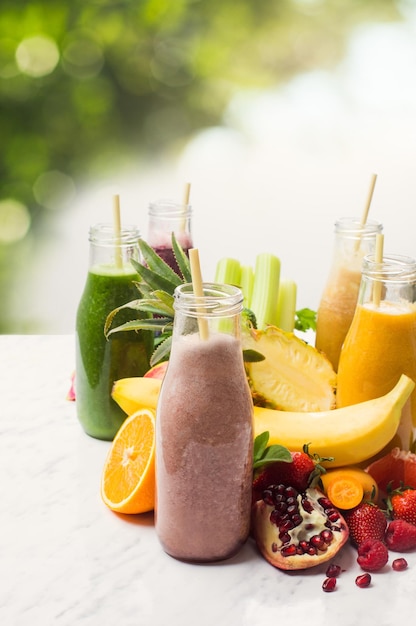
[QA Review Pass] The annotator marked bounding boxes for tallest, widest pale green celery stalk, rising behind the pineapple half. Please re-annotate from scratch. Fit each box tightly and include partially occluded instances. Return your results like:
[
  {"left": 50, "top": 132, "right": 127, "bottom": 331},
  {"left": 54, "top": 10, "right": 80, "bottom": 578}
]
[{"left": 250, "top": 252, "right": 280, "bottom": 330}]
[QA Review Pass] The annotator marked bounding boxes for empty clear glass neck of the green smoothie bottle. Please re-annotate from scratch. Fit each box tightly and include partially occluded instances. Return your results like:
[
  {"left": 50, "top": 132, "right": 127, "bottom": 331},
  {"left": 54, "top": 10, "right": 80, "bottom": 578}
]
[{"left": 89, "top": 224, "right": 140, "bottom": 273}]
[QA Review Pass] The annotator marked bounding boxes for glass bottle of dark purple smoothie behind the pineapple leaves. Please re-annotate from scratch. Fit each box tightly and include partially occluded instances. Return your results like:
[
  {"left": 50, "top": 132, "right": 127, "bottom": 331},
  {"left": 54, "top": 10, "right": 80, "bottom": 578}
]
[{"left": 147, "top": 200, "right": 193, "bottom": 273}]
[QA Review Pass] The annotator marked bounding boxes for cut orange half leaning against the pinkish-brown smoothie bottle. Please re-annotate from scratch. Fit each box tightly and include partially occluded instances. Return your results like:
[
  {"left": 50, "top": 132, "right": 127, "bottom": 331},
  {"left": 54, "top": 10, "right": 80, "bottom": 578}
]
[{"left": 101, "top": 409, "right": 155, "bottom": 513}]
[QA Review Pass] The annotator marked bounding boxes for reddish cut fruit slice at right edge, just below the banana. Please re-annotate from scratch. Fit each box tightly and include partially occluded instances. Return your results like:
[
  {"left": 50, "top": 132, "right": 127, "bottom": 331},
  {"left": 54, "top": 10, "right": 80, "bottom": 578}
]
[{"left": 367, "top": 448, "right": 416, "bottom": 493}]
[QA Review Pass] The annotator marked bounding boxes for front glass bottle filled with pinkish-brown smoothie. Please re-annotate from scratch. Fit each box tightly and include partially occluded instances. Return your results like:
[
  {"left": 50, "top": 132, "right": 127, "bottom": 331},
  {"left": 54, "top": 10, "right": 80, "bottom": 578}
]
[{"left": 155, "top": 283, "right": 253, "bottom": 562}]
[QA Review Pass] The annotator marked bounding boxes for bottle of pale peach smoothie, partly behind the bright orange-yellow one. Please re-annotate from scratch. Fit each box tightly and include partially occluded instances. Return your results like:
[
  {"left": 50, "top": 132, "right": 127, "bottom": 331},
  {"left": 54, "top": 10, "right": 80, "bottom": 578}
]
[{"left": 315, "top": 217, "right": 383, "bottom": 371}]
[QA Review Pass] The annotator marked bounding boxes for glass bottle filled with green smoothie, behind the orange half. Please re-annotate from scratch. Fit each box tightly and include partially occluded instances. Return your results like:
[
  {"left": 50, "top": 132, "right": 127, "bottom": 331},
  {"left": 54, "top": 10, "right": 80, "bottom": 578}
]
[{"left": 75, "top": 224, "right": 153, "bottom": 441}]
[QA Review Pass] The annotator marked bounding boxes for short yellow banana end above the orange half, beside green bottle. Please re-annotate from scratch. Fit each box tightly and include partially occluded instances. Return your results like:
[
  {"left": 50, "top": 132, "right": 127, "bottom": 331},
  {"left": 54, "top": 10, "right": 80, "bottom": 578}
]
[{"left": 111, "top": 376, "right": 162, "bottom": 415}]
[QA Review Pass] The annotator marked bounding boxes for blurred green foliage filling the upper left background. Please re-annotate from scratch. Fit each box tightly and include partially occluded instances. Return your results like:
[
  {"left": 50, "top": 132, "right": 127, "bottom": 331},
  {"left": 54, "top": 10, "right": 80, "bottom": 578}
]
[{"left": 0, "top": 0, "right": 400, "bottom": 333}]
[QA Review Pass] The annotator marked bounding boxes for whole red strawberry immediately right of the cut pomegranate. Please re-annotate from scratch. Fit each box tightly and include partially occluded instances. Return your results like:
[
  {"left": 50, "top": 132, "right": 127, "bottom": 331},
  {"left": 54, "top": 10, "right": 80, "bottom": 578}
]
[{"left": 344, "top": 502, "right": 387, "bottom": 546}]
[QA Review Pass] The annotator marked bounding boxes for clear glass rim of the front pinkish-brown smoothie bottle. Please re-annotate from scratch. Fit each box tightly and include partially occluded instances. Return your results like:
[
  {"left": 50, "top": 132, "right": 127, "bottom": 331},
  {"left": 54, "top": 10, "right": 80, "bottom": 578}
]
[{"left": 173, "top": 282, "right": 243, "bottom": 317}]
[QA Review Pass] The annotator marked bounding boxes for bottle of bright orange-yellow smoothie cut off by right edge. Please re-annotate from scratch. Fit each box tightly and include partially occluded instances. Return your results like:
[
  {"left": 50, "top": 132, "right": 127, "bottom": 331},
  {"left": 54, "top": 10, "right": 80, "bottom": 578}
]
[{"left": 337, "top": 255, "right": 416, "bottom": 450}]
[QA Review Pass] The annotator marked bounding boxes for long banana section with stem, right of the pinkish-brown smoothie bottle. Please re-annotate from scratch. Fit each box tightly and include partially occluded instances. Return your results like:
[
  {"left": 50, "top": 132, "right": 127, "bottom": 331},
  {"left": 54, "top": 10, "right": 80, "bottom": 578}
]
[{"left": 254, "top": 374, "right": 415, "bottom": 467}]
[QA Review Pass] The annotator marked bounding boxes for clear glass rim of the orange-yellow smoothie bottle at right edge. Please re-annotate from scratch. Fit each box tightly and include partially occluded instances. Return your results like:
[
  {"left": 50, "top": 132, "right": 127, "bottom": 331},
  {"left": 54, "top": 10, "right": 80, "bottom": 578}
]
[{"left": 362, "top": 253, "right": 416, "bottom": 283}]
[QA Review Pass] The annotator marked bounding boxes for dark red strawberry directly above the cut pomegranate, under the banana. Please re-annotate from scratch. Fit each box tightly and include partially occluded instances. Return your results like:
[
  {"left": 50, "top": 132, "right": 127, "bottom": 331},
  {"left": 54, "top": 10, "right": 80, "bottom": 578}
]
[{"left": 253, "top": 446, "right": 323, "bottom": 500}]
